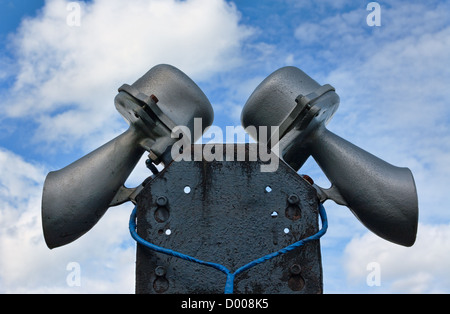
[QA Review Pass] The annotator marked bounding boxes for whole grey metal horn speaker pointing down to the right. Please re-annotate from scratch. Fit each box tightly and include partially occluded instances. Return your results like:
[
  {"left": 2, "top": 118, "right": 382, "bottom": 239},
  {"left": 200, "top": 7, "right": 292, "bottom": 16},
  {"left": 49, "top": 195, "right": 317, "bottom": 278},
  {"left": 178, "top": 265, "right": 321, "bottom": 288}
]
[{"left": 241, "top": 67, "right": 418, "bottom": 246}]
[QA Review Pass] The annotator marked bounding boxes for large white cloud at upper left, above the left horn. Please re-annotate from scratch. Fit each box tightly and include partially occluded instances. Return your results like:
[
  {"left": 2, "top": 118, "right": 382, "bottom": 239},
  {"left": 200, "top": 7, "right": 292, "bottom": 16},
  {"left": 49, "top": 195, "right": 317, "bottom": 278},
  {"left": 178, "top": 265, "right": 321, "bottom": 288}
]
[{"left": 0, "top": 0, "right": 252, "bottom": 152}]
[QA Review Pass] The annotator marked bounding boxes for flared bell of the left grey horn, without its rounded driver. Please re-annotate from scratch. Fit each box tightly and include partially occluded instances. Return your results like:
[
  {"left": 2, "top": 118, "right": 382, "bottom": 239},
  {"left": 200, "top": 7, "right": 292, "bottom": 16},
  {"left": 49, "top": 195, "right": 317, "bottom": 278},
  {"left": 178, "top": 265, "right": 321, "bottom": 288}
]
[{"left": 42, "top": 129, "right": 144, "bottom": 249}]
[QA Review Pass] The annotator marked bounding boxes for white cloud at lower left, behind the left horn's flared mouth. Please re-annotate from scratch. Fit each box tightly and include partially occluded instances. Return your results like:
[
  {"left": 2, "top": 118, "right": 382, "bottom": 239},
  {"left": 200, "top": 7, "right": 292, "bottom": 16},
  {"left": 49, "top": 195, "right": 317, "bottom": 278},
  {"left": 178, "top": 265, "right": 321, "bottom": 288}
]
[{"left": 0, "top": 149, "right": 135, "bottom": 293}]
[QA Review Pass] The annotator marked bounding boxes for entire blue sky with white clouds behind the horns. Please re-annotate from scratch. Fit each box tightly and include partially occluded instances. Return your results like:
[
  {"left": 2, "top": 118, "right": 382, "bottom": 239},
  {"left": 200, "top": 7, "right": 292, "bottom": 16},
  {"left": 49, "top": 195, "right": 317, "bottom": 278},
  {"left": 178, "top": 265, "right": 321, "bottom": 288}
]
[{"left": 0, "top": 0, "right": 450, "bottom": 293}]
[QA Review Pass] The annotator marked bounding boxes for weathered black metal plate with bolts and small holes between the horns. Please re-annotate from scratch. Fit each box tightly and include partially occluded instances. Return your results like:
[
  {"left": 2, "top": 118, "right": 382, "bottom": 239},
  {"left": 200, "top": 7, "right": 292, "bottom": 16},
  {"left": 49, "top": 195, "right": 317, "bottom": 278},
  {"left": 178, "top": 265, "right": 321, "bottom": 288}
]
[{"left": 136, "top": 144, "right": 323, "bottom": 294}]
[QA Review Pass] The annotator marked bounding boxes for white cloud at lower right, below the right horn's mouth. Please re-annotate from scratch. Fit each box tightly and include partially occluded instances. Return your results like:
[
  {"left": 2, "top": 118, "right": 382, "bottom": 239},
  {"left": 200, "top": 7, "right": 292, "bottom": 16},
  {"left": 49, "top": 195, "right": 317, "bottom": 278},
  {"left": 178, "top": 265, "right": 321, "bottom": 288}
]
[{"left": 344, "top": 224, "right": 450, "bottom": 293}]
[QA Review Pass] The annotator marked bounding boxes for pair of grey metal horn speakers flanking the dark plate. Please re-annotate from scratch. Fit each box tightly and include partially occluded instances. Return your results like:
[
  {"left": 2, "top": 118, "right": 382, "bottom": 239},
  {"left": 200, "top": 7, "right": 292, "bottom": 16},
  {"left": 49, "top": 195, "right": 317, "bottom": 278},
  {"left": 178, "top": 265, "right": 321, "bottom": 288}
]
[{"left": 42, "top": 65, "right": 418, "bottom": 248}]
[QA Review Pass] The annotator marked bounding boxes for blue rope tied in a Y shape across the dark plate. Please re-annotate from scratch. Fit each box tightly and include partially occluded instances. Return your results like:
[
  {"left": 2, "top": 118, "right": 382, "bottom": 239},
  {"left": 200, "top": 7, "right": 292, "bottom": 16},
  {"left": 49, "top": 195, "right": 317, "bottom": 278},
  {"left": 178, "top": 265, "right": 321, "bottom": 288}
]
[{"left": 129, "top": 203, "right": 328, "bottom": 294}]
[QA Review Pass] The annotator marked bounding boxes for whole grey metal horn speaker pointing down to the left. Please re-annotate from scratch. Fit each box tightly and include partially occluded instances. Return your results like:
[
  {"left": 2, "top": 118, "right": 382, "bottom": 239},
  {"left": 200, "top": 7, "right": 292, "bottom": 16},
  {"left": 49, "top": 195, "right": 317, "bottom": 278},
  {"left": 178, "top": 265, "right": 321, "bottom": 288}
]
[{"left": 42, "top": 64, "right": 214, "bottom": 248}]
